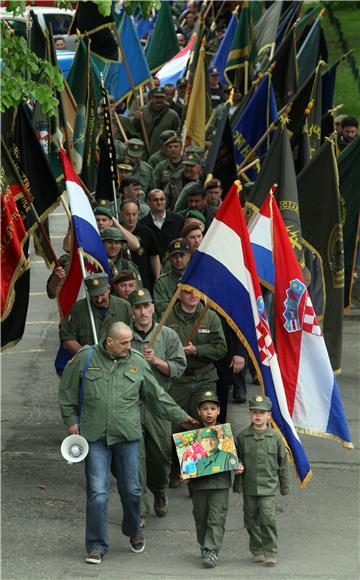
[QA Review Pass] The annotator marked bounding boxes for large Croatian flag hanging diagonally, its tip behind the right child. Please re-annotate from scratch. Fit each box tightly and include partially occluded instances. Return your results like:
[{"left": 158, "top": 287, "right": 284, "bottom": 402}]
[{"left": 181, "top": 185, "right": 311, "bottom": 486}]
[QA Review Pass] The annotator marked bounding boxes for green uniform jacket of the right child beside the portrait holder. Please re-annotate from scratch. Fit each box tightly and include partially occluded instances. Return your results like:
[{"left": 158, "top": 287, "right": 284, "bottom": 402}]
[{"left": 234, "top": 425, "right": 290, "bottom": 495}]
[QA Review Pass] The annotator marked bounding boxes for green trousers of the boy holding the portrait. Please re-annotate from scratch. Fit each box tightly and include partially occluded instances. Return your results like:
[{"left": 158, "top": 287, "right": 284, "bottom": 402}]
[{"left": 192, "top": 488, "right": 229, "bottom": 554}]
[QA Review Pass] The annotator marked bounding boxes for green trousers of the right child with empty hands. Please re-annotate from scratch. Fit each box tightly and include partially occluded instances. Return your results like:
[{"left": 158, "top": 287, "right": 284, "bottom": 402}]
[{"left": 244, "top": 495, "right": 277, "bottom": 556}]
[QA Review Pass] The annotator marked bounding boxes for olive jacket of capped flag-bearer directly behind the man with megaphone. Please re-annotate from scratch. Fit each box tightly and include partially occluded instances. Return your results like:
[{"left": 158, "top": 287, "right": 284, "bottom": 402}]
[{"left": 59, "top": 296, "right": 132, "bottom": 346}]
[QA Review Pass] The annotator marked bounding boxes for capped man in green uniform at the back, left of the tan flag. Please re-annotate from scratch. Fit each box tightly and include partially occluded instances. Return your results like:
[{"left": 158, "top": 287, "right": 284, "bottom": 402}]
[{"left": 132, "top": 87, "right": 180, "bottom": 155}]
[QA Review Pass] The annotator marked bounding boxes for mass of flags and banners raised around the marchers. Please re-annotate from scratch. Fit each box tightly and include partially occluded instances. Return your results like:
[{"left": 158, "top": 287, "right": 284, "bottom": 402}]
[{"left": 1, "top": 0, "right": 360, "bottom": 484}]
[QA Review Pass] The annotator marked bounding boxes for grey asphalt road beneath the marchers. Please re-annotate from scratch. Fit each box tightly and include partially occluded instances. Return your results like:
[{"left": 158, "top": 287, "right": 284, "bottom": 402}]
[{"left": 1, "top": 208, "right": 360, "bottom": 580}]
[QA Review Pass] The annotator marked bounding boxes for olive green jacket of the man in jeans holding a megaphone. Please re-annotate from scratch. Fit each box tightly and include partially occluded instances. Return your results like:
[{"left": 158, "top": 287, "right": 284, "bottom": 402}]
[{"left": 59, "top": 337, "right": 187, "bottom": 445}]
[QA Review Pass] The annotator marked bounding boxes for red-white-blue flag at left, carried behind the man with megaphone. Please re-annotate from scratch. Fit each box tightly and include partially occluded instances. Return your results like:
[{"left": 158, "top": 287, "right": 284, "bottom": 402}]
[{"left": 57, "top": 149, "right": 111, "bottom": 318}]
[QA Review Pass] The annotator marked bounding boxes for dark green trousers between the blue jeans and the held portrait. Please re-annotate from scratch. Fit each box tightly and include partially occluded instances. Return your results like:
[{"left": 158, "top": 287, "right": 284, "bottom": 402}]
[{"left": 139, "top": 406, "right": 172, "bottom": 517}]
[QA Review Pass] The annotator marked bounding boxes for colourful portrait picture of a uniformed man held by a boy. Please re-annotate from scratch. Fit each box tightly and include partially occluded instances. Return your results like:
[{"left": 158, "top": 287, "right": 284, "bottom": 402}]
[{"left": 173, "top": 423, "right": 238, "bottom": 480}]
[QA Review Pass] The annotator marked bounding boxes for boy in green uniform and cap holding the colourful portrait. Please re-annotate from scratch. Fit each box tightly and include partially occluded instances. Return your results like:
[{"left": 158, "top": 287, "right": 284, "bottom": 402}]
[{"left": 189, "top": 391, "right": 242, "bottom": 568}]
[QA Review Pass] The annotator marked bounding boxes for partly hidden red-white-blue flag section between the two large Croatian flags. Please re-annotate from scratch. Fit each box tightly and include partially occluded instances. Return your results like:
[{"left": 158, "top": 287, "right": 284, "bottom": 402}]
[{"left": 248, "top": 193, "right": 275, "bottom": 290}]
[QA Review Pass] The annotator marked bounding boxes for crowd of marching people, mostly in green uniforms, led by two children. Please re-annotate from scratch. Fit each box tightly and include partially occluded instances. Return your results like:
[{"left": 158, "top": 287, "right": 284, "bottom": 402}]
[{"left": 31, "top": 2, "right": 358, "bottom": 568}]
